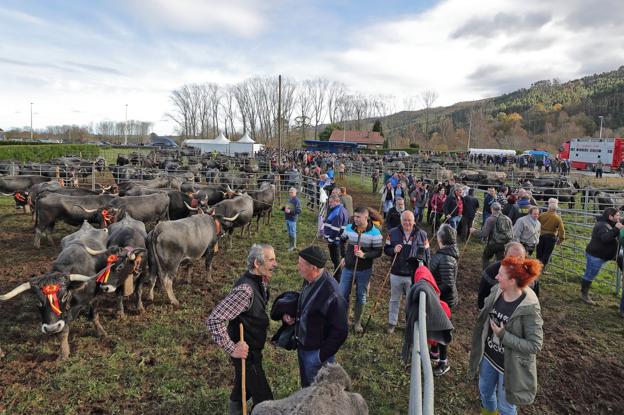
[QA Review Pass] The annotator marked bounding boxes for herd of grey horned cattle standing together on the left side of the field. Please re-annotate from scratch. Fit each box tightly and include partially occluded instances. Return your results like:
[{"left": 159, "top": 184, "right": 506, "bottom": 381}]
[{"left": 0, "top": 175, "right": 275, "bottom": 358}]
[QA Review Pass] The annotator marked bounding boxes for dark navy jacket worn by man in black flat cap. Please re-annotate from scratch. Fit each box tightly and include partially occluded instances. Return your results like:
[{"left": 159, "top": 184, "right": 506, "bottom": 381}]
[{"left": 295, "top": 271, "right": 349, "bottom": 362}]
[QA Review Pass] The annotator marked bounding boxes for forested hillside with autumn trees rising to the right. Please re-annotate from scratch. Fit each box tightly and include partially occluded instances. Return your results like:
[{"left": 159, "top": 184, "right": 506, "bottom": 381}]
[{"left": 378, "top": 66, "right": 624, "bottom": 150}]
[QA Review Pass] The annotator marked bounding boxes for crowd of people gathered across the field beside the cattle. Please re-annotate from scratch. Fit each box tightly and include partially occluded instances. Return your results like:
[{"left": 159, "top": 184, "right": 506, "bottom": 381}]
[{"left": 208, "top": 156, "right": 624, "bottom": 414}]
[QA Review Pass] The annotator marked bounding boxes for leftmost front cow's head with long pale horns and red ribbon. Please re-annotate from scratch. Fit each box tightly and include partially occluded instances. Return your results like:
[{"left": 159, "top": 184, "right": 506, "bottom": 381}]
[{"left": 0, "top": 272, "right": 91, "bottom": 334}]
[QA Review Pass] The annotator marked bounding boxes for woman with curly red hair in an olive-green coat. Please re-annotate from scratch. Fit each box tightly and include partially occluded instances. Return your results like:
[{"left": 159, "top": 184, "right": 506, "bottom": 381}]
[{"left": 469, "top": 257, "right": 544, "bottom": 415}]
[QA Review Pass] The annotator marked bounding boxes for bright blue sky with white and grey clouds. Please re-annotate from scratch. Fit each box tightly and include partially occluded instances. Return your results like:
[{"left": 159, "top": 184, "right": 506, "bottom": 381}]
[{"left": 0, "top": 0, "right": 624, "bottom": 134}]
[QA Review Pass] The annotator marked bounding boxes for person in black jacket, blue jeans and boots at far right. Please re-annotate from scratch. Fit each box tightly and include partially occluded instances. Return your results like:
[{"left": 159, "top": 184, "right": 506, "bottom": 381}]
[{"left": 581, "top": 207, "right": 624, "bottom": 304}]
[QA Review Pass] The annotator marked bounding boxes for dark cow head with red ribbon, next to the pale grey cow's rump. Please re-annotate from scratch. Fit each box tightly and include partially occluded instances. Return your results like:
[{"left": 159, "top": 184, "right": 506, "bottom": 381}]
[{"left": 95, "top": 247, "right": 146, "bottom": 293}]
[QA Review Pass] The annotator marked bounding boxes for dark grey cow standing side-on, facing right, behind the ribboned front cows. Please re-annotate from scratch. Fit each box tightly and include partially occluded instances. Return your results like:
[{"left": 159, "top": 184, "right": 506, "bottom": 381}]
[{"left": 34, "top": 193, "right": 116, "bottom": 248}]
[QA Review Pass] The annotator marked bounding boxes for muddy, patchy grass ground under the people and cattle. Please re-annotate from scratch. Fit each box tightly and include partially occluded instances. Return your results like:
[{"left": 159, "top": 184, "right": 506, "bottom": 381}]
[{"left": 0, "top": 187, "right": 624, "bottom": 414}]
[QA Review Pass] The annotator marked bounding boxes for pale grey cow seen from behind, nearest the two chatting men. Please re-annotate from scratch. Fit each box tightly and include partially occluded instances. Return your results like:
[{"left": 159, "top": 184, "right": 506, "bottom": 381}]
[{"left": 146, "top": 214, "right": 237, "bottom": 307}]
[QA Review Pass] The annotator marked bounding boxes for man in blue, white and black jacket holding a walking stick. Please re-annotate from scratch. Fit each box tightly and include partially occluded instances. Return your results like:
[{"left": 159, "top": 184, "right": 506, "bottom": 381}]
[{"left": 339, "top": 207, "right": 383, "bottom": 333}]
